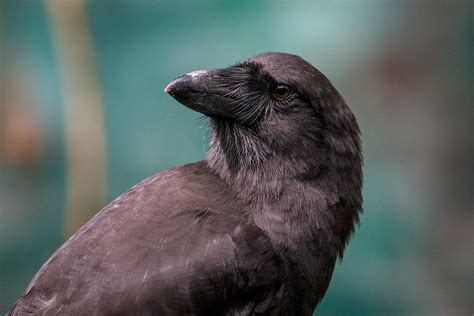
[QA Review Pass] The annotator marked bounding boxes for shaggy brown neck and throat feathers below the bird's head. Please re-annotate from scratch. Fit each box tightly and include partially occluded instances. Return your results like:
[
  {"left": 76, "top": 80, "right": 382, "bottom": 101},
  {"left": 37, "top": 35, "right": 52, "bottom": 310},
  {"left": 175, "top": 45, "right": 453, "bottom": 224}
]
[{"left": 207, "top": 118, "right": 362, "bottom": 256}]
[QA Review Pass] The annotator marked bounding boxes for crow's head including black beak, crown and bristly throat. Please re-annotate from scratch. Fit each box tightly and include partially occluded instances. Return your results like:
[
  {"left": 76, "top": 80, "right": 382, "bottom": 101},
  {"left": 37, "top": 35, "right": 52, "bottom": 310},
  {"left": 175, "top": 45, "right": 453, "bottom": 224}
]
[{"left": 165, "top": 53, "right": 361, "bottom": 191}]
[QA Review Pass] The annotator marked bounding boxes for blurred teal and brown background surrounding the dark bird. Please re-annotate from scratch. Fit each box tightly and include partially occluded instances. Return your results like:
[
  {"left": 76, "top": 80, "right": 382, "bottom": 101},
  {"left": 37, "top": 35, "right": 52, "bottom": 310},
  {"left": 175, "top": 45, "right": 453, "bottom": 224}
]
[{"left": 0, "top": 0, "right": 474, "bottom": 315}]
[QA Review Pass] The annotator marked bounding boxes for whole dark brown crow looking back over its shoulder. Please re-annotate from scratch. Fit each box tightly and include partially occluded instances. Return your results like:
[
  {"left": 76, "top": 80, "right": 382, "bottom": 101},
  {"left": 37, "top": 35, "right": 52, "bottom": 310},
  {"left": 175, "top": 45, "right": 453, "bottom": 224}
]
[{"left": 10, "top": 53, "right": 362, "bottom": 315}]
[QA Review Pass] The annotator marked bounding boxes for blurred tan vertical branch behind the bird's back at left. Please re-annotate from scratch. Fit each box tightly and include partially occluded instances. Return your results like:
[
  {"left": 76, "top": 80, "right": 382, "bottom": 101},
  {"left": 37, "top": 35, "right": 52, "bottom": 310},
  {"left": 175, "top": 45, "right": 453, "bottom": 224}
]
[{"left": 46, "top": 0, "right": 107, "bottom": 235}]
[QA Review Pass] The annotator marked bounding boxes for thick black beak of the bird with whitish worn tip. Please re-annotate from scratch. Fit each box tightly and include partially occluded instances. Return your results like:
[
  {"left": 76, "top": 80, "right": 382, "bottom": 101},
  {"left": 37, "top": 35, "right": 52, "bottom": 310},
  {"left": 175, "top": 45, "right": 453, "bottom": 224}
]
[{"left": 165, "top": 70, "right": 235, "bottom": 119}]
